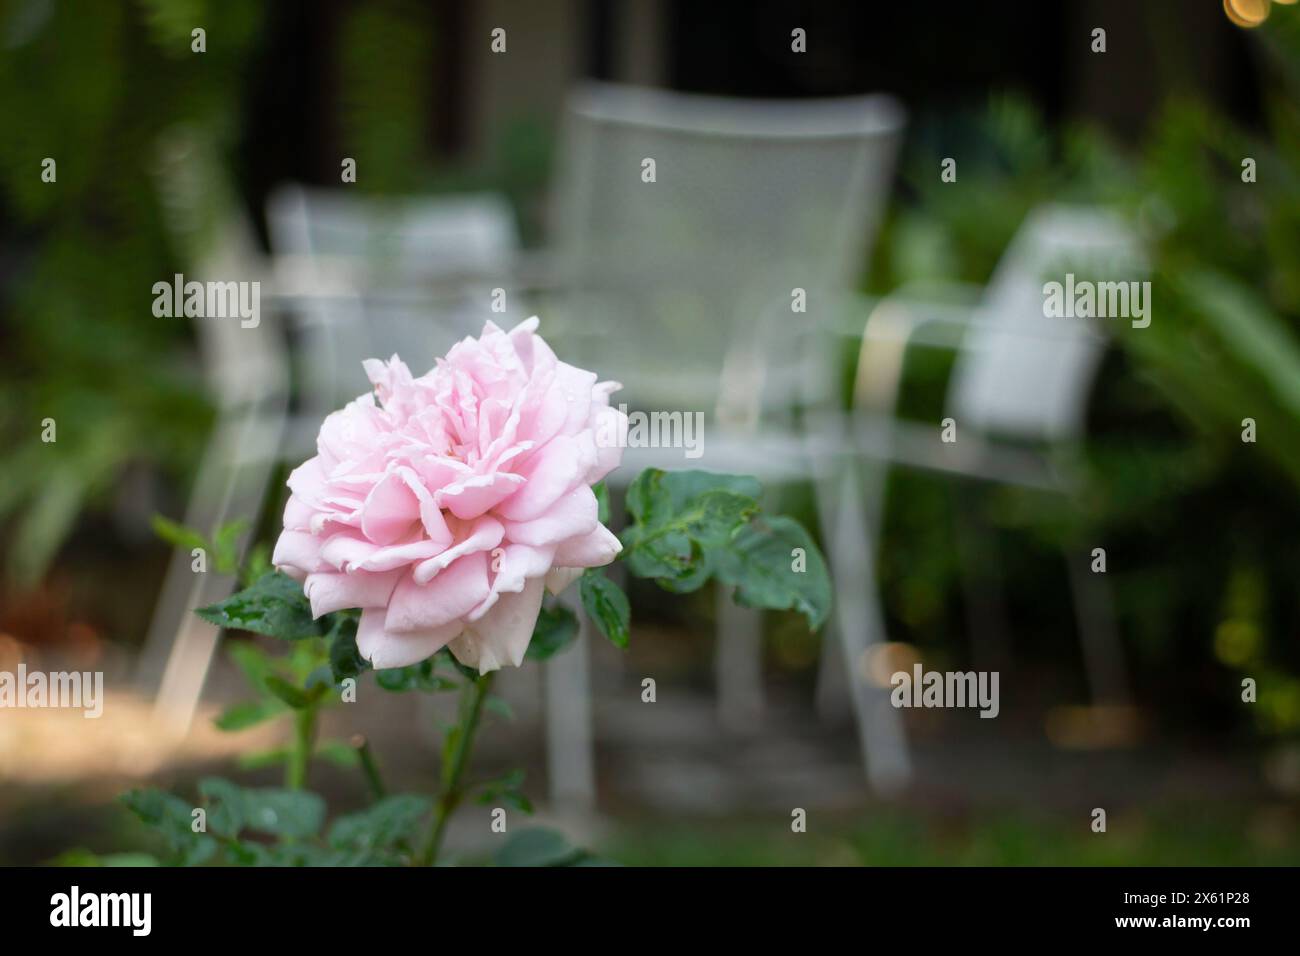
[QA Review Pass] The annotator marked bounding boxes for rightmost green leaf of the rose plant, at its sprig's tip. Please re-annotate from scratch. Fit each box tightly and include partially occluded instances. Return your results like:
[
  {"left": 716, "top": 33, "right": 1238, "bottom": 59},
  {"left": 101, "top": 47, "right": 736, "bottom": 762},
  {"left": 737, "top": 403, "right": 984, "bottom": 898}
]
[{"left": 718, "top": 516, "right": 831, "bottom": 631}]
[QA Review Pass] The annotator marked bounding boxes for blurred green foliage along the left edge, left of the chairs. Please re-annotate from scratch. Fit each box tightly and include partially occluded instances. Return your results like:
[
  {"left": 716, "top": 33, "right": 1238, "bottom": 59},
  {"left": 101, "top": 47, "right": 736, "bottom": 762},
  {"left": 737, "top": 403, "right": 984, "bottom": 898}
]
[{"left": 0, "top": 0, "right": 264, "bottom": 585}]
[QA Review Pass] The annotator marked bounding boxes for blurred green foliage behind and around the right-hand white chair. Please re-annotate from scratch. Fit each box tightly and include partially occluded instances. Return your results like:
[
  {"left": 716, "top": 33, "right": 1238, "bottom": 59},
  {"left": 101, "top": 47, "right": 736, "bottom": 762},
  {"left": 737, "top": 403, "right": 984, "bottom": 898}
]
[{"left": 852, "top": 27, "right": 1300, "bottom": 734}]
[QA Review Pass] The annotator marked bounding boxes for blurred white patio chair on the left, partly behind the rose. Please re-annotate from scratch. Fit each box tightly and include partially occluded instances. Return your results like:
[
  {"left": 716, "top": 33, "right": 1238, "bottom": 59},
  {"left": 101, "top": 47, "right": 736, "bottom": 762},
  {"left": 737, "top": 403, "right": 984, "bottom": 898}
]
[{"left": 140, "top": 175, "right": 517, "bottom": 732}]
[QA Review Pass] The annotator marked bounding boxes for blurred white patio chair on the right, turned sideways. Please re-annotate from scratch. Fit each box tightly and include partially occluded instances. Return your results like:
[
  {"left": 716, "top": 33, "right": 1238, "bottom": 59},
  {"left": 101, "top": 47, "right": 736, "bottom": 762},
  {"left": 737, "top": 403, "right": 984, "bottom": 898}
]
[{"left": 810, "top": 206, "right": 1144, "bottom": 788}]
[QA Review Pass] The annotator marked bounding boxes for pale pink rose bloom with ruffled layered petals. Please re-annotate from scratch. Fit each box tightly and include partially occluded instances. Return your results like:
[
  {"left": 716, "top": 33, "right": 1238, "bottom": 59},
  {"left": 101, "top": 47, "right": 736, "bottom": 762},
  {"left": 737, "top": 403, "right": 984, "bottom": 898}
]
[{"left": 272, "top": 317, "right": 627, "bottom": 674}]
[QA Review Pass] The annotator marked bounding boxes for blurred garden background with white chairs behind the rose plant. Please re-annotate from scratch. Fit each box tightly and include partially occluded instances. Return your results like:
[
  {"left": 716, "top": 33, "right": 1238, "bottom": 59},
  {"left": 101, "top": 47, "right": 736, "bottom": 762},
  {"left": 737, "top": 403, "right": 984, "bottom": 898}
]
[{"left": 0, "top": 0, "right": 1300, "bottom": 865}]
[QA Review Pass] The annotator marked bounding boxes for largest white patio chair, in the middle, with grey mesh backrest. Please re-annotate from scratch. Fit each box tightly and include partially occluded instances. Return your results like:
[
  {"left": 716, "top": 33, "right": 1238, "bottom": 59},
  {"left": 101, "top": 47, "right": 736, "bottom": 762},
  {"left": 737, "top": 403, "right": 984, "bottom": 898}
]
[{"left": 547, "top": 83, "right": 902, "bottom": 785}]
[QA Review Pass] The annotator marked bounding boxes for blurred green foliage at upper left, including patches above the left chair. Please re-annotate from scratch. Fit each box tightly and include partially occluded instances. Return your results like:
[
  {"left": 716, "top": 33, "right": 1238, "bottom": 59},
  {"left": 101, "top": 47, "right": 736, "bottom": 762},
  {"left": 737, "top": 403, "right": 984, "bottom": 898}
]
[{"left": 0, "top": 0, "right": 550, "bottom": 598}]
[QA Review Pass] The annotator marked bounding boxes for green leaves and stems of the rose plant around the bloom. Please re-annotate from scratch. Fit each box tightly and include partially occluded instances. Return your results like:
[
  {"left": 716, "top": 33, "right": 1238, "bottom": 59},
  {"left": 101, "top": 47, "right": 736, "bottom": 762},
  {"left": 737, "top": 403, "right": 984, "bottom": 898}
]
[{"left": 101, "top": 468, "right": 831, "bottom": 866}]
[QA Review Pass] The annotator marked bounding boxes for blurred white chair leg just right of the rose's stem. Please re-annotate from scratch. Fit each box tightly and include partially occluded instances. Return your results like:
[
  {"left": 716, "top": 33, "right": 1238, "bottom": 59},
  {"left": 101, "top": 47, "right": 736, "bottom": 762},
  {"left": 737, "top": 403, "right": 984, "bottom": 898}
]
[{"left": 545, "top": 587, "right": 595, "bottom": 813}]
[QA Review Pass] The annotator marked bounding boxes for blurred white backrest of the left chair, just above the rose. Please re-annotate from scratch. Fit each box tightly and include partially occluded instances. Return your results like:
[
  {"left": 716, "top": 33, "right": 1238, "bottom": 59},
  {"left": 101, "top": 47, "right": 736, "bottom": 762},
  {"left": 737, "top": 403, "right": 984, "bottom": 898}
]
[{"left": 267, "top": 185, "right": 519, "bottom": 458}]
